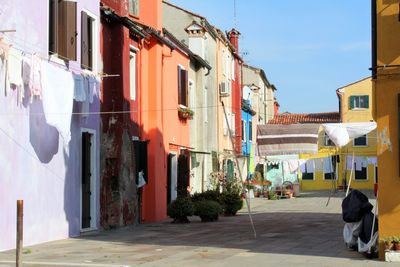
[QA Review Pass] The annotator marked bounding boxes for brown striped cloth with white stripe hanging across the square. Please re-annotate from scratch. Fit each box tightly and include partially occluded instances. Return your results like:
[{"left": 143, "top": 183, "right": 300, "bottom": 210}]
[{"left": 257, "top": 124, "right": 320, "bottom": 156}]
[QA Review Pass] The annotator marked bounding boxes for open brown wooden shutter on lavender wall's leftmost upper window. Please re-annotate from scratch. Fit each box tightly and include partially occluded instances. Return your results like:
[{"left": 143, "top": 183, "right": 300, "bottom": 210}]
[{"left": 57, "top": 0, "right": 77, "bottom": 60}]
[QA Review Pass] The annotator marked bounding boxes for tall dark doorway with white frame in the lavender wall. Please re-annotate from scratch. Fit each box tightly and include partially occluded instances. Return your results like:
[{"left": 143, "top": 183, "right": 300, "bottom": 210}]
[{"left": 80, "top": 130, "right": 96, "bottom": 230}]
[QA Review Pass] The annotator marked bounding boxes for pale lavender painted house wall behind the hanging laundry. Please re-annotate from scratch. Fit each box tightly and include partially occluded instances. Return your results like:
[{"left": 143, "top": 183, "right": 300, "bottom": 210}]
[{"left": 0, "top": 0, "right": 101, "bottom": 251}]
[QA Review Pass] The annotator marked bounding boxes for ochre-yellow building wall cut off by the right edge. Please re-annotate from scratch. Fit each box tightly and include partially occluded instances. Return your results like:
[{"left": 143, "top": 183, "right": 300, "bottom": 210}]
[{"left": 372, "top": 0, "right": 400, "bottom": 256}]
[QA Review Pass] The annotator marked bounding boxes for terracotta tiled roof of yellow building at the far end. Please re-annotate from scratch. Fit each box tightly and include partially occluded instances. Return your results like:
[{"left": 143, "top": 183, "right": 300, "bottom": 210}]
[{"left": 268, "top": 112, "right": 340, "bottom": 124}]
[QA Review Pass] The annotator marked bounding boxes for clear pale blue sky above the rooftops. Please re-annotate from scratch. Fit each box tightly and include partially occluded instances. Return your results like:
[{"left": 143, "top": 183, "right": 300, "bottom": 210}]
[{"left": 170, "top": 0, "right": 371, "bottom": 113}]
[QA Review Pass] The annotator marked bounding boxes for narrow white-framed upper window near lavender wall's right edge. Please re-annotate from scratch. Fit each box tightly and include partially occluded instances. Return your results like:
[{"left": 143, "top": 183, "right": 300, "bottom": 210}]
[{"left": 81, "top": 11, "right": 96, "bottom": 70}]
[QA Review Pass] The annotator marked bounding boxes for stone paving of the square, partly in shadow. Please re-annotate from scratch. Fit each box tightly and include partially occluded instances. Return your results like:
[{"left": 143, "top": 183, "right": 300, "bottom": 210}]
[{"left": 0, "top": 192, "right": 398, "bottom": 267}]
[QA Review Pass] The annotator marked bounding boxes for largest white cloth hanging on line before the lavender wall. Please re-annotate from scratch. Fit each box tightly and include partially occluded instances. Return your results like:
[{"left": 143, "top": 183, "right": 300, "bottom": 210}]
[{"left": 42, "top": 62, "right": 74, "bottom": 148}]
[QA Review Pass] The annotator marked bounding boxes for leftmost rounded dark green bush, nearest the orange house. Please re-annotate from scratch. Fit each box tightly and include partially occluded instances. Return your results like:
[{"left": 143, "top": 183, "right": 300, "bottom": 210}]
[{"left": 167, "top": 197, "right": 194, "bottom": 223}]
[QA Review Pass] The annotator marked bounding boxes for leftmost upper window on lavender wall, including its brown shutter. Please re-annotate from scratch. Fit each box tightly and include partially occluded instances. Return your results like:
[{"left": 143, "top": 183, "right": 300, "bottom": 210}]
[{"left": 49, "top": 0, "right": 77, "bottom": 60}]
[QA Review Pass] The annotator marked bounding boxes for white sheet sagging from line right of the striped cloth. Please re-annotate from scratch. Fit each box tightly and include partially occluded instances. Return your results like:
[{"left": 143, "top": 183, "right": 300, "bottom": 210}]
[{"left": 322, "top": 122, "right": 376, "bottom": 147}]
